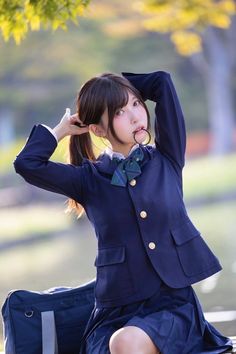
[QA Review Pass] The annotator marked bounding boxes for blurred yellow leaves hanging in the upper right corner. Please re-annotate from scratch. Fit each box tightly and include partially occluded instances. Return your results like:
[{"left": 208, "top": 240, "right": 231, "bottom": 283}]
[{"left": 137, "top": 0, "right": 236, "bottom": 56}]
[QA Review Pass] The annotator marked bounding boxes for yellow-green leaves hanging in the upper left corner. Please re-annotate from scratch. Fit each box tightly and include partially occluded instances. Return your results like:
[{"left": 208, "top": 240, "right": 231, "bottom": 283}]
[{"left": 0, "top": 0, "right": 90, "bottom": 44}]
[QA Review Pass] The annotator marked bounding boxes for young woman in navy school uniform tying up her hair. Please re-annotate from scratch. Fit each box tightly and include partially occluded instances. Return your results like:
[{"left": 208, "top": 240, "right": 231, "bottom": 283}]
[{"left": 15, "top": 71, "right": 232, "bottom": 354}]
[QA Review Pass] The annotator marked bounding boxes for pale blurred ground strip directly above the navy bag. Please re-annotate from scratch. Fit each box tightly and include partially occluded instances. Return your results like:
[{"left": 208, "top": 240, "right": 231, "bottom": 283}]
[{"left": 0, "top": 221, "right": 96, "bottom": 348}]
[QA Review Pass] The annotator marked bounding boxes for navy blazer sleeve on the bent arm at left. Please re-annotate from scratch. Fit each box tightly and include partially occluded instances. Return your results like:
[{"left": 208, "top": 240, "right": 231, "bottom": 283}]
[{"left": 14, "top": 125, "right": 86, "bottom": 205}]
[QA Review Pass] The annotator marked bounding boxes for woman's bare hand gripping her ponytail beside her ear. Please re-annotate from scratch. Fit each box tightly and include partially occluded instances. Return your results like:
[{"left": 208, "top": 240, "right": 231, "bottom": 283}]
[{"left": 53, "top": 108, "right": 89, "bottom": 141}]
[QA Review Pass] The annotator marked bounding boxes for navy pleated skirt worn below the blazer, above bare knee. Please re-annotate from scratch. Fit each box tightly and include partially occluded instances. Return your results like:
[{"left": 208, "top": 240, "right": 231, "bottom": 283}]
[{"left": 80, "top": 283, "right": 232, "bottom": 354}]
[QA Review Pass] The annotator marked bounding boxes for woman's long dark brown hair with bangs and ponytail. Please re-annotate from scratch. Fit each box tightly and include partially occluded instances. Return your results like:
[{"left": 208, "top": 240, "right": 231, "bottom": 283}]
[{"left": 67, "top": 73, "right": 150, "bottom": 217}]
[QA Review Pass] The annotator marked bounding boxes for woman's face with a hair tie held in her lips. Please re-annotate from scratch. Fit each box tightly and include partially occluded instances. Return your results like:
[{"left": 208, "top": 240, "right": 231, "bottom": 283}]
[{"left": 101, "top": 92, "right": 148, "bottom": 156}]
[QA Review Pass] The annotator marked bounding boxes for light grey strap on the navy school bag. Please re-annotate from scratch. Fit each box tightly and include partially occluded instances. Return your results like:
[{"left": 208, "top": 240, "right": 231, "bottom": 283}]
[{"left": 41, "top": 311, "right": 58, "bottom": 354}]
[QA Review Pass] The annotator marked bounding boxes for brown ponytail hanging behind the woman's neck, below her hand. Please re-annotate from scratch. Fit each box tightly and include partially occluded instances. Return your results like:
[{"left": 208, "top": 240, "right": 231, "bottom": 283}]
[{"left": 66, "top": 132, "right": 96, "bottom": 218}]
